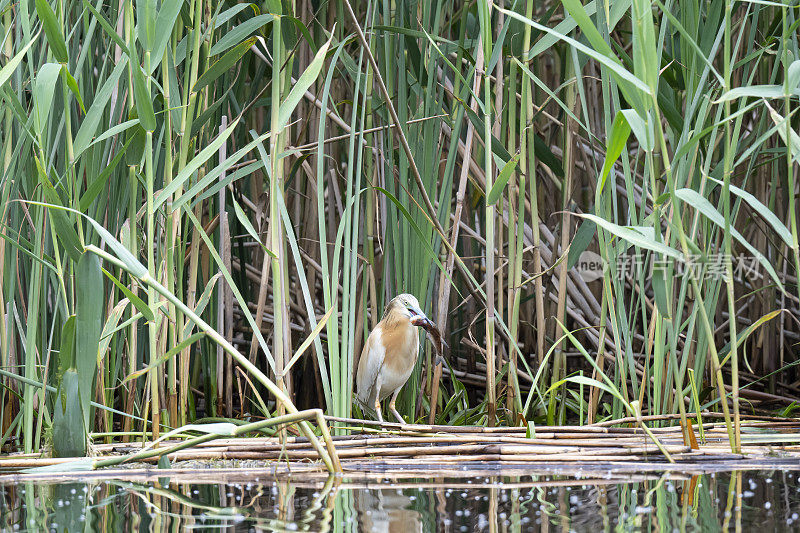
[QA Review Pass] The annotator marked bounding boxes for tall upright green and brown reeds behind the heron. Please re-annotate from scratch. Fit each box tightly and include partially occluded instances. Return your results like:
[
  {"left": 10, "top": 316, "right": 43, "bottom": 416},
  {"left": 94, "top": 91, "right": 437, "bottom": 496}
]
[{"left": 0, "top": 0, "right": 800, "bottom": 468}]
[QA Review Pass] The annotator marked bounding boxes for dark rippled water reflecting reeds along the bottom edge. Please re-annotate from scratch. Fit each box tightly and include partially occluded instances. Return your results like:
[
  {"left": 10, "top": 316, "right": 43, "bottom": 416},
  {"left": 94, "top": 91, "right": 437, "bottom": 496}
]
[{"left": 0, "top": 471, "right": 800, "bottom": 532}]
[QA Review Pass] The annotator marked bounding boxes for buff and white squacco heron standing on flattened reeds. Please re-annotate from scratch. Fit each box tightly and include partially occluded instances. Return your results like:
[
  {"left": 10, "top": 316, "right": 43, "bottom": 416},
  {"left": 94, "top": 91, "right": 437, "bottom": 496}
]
[{"left": 356, "top": 294, "right": 430, "bottom": 424}]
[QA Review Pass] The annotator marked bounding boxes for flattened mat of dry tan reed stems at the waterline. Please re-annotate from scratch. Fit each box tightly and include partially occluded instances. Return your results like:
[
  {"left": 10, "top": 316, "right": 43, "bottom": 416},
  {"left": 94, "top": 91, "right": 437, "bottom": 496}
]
[{"left": 0, "top": 420, "right": 800, "bottom": 479}]
